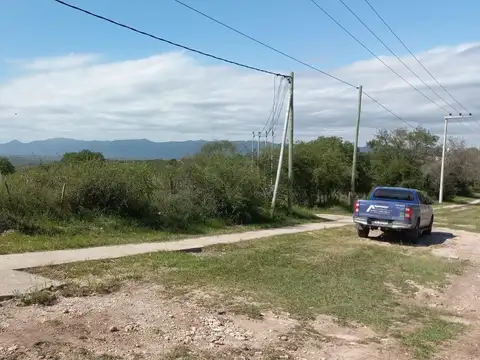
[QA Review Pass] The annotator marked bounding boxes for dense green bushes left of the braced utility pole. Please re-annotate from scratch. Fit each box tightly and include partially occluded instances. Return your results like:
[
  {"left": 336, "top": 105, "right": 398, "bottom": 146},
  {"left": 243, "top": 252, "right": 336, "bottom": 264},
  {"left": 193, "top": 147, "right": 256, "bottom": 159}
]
[{"left": 0, "top": 153, "right": 267, "bottom": 233}]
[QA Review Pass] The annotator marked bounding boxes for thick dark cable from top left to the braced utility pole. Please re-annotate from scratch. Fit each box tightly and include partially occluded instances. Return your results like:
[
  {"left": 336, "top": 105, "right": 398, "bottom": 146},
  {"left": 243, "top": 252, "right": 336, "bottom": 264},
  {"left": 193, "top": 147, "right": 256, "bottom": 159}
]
[{"left": 53, "top": 0, "right": 289, "bottom": 77}]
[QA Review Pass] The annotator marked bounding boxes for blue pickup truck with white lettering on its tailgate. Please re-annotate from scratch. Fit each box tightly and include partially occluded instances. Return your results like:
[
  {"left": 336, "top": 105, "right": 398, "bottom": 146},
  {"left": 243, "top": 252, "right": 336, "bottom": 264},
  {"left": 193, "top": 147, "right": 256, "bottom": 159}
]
[{"left": 353, "top": 187, "right": 434, "bottom": 242}]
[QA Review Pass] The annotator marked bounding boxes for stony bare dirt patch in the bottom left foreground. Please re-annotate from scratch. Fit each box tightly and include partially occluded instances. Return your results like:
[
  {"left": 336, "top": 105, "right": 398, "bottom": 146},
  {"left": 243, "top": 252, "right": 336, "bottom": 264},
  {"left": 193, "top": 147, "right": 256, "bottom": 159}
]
[{"left": 0, "top": 285, "right": 407, "bottom": 360}]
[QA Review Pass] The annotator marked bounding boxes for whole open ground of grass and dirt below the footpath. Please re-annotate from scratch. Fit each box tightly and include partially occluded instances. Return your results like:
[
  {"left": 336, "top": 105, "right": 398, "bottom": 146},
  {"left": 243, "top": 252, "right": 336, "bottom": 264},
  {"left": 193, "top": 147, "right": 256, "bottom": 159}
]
[{"left": 0, "top": 226, "right": 480, "bottom": 360}]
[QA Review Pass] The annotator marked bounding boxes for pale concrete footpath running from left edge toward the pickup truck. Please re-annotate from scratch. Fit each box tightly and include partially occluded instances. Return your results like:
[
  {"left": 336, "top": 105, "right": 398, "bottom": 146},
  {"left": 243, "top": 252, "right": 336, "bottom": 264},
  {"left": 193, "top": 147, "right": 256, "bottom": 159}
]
[{"left": 0, "top": 214, "right": 352, "bottom": 298}]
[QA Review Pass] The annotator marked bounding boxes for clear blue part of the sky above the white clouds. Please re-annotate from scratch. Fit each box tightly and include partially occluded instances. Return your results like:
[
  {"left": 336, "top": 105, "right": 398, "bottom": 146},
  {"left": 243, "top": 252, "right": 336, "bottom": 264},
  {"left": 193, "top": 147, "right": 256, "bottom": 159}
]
[{"left": 0, "top": 0, "right": 480, "bottom": 70}]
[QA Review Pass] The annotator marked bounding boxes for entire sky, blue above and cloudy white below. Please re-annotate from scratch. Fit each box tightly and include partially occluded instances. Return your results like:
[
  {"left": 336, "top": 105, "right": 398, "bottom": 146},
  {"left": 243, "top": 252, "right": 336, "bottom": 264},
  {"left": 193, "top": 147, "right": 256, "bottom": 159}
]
[{"left": 0, "top": 0, "right": 480, "bottom": 146}]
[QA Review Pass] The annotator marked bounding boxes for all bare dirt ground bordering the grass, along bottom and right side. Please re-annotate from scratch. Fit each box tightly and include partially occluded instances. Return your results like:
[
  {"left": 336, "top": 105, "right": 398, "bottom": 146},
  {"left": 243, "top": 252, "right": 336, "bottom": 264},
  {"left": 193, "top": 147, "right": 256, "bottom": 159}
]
[{"left": 0, "top": 225, "right": 480, "bottom": 360}]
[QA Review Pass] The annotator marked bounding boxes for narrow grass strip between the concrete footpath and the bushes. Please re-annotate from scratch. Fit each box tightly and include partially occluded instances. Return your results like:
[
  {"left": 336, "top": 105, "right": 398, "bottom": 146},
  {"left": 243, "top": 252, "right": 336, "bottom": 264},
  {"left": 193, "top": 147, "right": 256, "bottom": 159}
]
[{"left": 0, "top": 208, "right": 322, "bottom": 254}]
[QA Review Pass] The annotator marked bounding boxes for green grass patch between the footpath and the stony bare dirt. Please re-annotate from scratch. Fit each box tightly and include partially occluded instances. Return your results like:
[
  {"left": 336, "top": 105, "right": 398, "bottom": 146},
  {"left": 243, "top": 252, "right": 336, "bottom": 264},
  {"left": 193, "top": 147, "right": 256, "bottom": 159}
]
[{"left": 32, "top": 227, "right": 464, "bottom": 359}]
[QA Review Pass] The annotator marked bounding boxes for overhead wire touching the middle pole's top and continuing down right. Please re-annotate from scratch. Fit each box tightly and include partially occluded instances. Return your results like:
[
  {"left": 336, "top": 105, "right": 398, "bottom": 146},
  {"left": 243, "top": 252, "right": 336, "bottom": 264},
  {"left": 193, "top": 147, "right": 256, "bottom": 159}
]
[{"left": 173, "top": 0, "right": 415, "bottom": 128}]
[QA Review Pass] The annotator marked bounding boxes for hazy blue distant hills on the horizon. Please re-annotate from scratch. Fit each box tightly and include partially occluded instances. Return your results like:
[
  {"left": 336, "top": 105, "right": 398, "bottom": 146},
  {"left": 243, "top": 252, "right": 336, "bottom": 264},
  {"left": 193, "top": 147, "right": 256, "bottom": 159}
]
[{"left": 0, "top": 138, "right": 369, "bottom": 165}]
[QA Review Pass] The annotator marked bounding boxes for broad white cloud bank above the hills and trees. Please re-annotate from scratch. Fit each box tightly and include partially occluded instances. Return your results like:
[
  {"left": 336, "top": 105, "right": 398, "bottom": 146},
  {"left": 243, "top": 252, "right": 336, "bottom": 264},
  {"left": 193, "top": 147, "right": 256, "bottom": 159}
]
[{"left": 0, "top": 43, "right": 480, "bottom": 145}]
